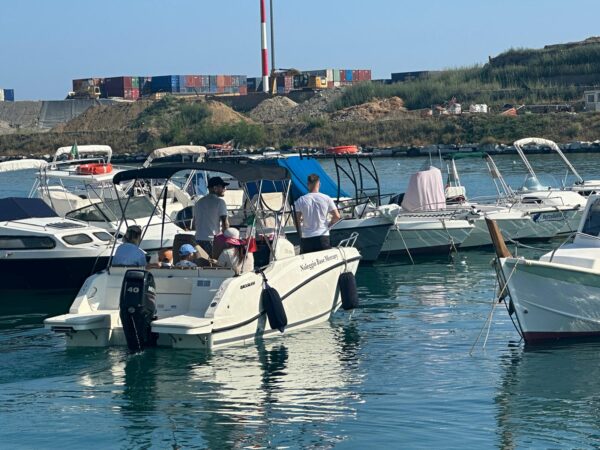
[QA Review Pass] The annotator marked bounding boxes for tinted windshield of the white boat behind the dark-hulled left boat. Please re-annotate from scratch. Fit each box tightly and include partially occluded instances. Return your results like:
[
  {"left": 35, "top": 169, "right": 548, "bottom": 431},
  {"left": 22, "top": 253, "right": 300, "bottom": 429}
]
[{"left": 67, "top": 197, "right": 154, "bottom": 222}]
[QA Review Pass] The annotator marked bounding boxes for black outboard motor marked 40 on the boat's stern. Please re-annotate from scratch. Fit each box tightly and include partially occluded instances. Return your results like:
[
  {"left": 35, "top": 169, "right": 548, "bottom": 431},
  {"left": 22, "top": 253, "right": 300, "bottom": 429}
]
[{"left": 119, "top": 269, "right": 158, "bottom": 352}]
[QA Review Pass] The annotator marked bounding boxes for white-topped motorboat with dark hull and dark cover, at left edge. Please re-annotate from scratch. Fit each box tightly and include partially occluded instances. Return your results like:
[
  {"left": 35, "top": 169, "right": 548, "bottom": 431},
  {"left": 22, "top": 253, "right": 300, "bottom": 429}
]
[{"left": 0, "top": 197, "right": 115, "bottom": 290}]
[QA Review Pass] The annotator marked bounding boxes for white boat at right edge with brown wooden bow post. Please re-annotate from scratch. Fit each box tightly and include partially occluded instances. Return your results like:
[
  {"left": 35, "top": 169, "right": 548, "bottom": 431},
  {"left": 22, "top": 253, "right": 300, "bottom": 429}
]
[{"left": 490, "top": 195, "right": 600, "bottom": 343}]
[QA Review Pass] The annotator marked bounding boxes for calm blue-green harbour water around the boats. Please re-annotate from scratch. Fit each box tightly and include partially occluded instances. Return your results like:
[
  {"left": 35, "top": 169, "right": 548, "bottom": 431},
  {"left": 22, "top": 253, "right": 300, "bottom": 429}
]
[{"left": 0, "top": 155, "right": 600, "bottom": 449}]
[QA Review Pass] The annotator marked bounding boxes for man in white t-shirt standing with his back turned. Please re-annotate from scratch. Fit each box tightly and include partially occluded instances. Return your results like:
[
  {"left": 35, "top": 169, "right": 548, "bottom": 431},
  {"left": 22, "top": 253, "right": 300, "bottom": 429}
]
[{"left": 294, "top": 173, "right": 340, "bottom": 253}]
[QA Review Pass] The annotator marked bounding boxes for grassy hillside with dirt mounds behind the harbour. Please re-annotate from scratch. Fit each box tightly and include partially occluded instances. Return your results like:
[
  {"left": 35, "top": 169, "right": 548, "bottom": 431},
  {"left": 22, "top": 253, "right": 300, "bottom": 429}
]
[{"left": 0, "top": 37, "right": 600, "bottom": 156}]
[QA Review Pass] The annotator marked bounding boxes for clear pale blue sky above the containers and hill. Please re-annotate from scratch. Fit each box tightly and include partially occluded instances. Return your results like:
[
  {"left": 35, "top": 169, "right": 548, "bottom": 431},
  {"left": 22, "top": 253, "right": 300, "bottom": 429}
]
[{"left": 0, "top": 0, "right": 600, "bottom": 100}]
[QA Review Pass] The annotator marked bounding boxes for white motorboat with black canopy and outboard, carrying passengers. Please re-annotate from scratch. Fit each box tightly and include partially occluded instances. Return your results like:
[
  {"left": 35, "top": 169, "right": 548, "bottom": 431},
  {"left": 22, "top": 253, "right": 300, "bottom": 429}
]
[{"left": 44, "top": 163, "right": 360, "bottom": 350}]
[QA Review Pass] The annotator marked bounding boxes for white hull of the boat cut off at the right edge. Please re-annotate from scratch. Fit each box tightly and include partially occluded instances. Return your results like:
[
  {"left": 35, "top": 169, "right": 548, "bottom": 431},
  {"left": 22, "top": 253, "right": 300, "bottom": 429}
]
[{"left": 501, "top": 258, "right": 600, "bottom": 344}]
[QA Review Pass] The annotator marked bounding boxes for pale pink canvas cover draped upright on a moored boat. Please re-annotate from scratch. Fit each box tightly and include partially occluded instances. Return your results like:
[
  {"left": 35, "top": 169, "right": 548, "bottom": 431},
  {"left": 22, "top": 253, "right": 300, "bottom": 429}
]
[{"left": 400, "top": 167, "right": 446, "bottom": 212}]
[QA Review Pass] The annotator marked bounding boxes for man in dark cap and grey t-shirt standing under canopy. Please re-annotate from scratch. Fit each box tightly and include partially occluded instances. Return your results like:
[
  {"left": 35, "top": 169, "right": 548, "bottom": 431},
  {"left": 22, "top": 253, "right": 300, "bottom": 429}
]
[{"left": 194, "top": 177, "right": 229, "bottom": 255}]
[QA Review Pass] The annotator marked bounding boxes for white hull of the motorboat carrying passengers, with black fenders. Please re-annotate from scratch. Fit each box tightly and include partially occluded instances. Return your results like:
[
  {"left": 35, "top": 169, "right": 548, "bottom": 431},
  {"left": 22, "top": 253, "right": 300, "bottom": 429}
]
[{"left": 45, "top": 247, "right": 360, "bottom": 349}]
